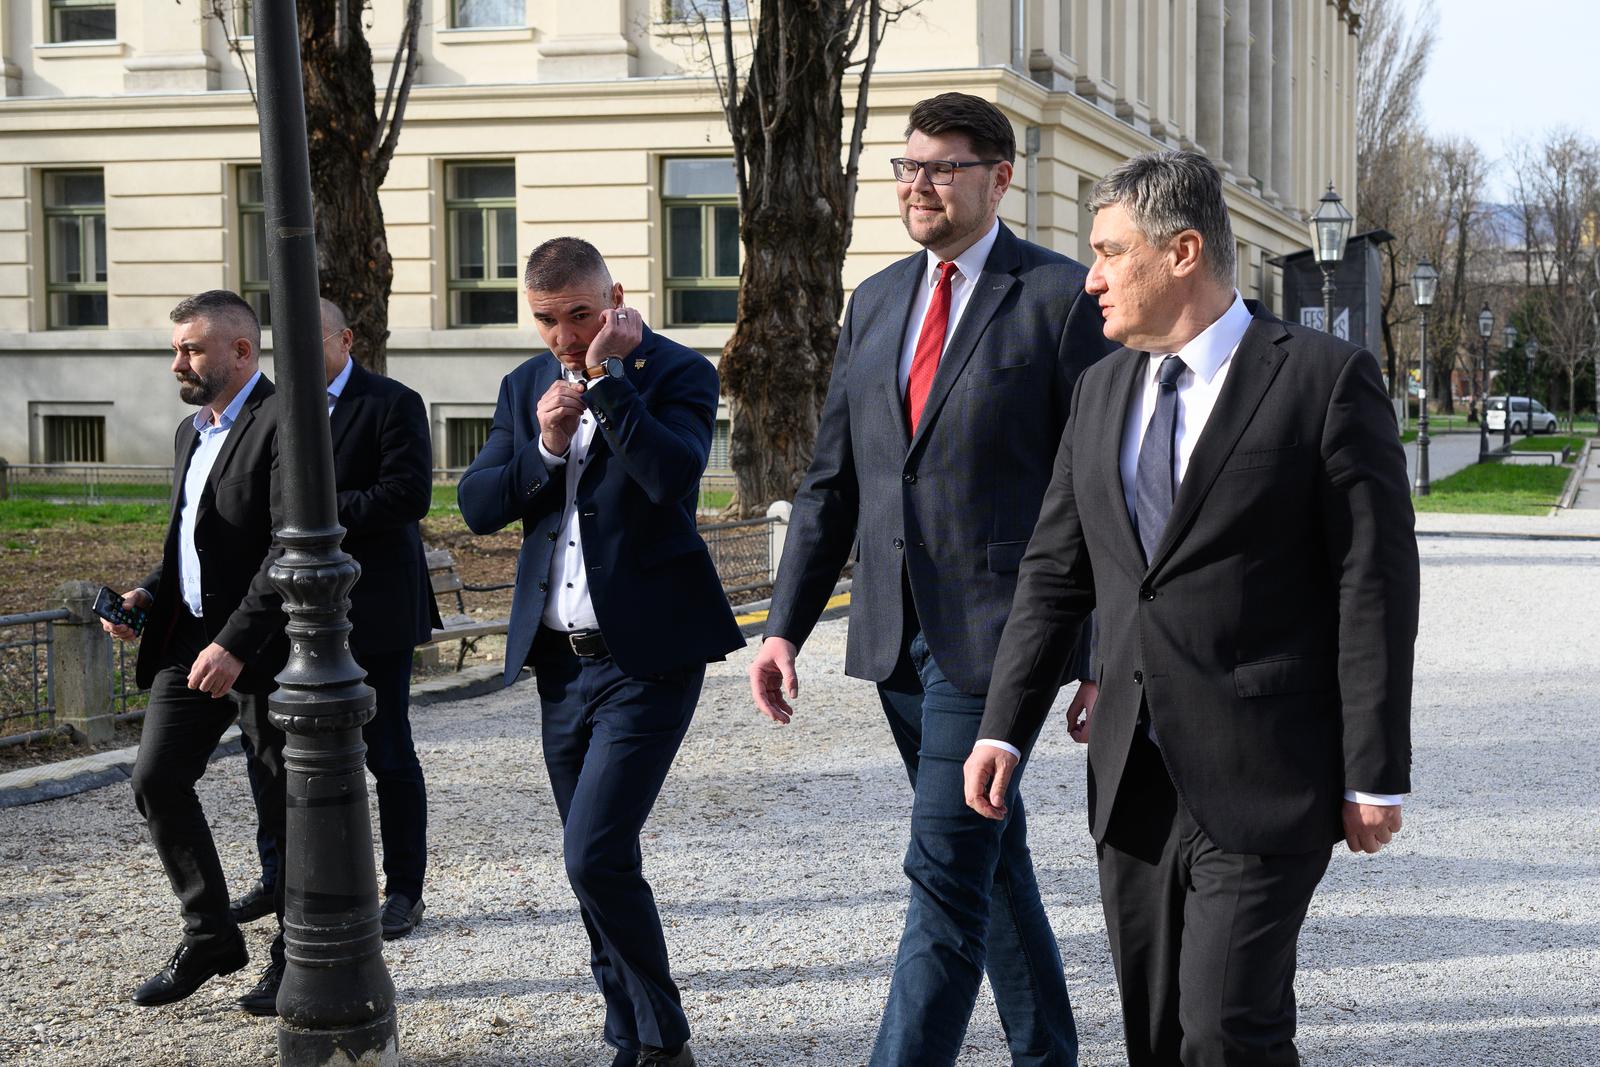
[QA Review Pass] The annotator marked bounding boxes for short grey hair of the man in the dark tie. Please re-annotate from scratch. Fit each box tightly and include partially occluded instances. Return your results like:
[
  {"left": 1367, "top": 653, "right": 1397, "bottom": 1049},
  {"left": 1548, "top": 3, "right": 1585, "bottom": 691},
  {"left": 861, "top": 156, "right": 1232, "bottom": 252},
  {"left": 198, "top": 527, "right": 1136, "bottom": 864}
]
[{"left": 1088, "top": 152, "right": 1234, "bottom": 285}]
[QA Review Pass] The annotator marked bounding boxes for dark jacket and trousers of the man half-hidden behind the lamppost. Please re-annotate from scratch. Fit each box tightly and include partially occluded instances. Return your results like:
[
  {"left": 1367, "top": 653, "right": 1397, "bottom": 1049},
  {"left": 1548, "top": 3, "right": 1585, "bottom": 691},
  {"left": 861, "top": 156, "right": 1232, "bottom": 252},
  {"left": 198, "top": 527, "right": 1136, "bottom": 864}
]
[{"left": 238, "top": 363, "right": 438, "bottom": 901}]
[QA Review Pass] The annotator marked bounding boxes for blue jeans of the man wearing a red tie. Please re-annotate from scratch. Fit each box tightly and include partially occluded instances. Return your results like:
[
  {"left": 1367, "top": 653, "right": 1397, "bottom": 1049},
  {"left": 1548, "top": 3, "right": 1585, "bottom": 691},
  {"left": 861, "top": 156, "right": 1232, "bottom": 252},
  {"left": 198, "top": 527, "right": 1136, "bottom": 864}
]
[{"left": 872, "top": 633, "right": 1078, "bottom": 1067}]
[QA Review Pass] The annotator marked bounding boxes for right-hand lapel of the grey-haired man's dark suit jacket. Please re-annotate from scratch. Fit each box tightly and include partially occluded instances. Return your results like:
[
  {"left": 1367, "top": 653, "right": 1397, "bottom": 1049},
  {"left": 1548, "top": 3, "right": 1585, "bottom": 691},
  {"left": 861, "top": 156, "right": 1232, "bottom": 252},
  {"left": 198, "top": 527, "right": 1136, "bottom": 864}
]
[{"left": 1150, "top": 317, "right": 1285, "bottom": 571}]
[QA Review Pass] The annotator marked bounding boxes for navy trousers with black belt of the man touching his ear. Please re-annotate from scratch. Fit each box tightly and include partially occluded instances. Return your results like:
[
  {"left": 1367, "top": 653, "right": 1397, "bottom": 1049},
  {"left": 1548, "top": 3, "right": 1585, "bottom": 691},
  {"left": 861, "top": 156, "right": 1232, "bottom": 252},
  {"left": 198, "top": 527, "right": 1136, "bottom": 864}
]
[{"left": 530, "top": 629, "right": 706, "bottom": 1051}]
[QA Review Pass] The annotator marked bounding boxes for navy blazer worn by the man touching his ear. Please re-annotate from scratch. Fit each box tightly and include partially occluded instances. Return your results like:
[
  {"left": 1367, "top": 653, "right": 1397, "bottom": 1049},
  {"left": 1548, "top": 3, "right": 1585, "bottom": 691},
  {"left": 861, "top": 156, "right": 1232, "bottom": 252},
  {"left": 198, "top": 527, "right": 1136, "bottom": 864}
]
[{"left": 458, "top": 328, "right": 744, "bottom": 685}]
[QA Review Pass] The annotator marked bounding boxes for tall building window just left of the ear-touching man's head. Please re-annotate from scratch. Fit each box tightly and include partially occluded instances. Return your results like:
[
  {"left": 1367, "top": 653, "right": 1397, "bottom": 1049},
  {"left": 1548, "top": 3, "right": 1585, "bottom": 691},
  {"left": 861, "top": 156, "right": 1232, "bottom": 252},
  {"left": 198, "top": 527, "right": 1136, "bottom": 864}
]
[{"left": 445, "top": 162, "right": 518, "bottom": 326}]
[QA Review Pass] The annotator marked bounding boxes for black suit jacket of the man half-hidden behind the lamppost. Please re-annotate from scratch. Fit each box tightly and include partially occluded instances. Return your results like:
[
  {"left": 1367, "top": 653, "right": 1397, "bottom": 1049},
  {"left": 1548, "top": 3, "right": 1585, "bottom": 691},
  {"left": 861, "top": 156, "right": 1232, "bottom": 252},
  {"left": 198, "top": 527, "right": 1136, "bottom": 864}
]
[{"left": 330, "top": 363, "right": 440, "bottom": 659}]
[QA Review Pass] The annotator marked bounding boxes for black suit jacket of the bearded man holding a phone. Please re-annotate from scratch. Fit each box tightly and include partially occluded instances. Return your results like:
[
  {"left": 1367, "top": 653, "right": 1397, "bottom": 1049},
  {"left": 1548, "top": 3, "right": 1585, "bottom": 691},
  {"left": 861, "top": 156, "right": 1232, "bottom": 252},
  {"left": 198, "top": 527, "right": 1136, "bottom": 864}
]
[{"left": 134, "top": 374, "right": 288, "bottom": 693}]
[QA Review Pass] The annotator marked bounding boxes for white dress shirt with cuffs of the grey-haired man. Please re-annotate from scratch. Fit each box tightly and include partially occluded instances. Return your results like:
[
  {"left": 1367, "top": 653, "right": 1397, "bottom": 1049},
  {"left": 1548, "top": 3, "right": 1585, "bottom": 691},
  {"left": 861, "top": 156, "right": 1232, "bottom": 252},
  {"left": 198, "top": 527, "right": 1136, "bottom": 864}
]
[{"left": 979, "top": 290, "right": 1403, "bottom": 805}]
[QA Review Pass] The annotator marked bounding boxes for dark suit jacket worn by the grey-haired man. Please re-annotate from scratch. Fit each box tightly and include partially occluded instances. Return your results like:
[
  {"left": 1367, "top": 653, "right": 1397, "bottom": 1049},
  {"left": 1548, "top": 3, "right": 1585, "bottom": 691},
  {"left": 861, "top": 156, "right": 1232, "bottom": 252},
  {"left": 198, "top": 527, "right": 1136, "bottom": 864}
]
[{"left": 979, "top": 304, "right": 1419, "bottom": 854}]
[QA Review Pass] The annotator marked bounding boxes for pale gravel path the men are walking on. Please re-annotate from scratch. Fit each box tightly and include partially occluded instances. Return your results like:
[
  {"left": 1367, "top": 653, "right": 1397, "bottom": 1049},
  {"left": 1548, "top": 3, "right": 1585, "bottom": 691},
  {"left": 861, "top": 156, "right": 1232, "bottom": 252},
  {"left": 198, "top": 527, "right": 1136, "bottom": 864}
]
[{"left": 0, "top": 531, "right": 1600, "bottom": 1067}]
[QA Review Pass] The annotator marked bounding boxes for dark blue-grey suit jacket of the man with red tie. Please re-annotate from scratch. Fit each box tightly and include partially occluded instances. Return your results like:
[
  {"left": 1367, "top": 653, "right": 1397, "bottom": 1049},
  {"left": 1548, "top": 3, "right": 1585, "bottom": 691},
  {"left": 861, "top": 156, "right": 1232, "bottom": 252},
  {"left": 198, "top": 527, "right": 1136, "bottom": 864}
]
[{"left": 766, "top": 226, "right": 1106, "bottom": 694}]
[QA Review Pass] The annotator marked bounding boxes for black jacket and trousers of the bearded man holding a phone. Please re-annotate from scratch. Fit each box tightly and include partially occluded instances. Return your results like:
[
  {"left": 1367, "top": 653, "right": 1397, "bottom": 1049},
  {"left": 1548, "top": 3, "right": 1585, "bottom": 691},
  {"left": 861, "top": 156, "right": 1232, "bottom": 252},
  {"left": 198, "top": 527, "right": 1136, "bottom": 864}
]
[{"left": 133, "top": 376, "right": 288, "bottom": 955}]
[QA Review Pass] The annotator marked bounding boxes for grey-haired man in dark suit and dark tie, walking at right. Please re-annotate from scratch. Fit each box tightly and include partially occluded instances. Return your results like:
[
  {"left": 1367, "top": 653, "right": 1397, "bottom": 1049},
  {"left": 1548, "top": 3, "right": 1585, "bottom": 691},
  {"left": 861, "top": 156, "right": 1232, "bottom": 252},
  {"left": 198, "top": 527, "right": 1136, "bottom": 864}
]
[{"left": 966, "top": 152, "right": 1419, "bottom": 1067}]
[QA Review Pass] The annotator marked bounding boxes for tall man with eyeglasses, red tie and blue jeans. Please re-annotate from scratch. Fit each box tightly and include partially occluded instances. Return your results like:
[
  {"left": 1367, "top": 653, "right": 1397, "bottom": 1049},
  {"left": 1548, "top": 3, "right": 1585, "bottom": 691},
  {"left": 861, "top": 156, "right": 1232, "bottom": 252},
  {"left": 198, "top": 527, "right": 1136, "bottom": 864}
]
[{"left": 749, "top": 93, "right": 1107, "bottom": 1067}]
